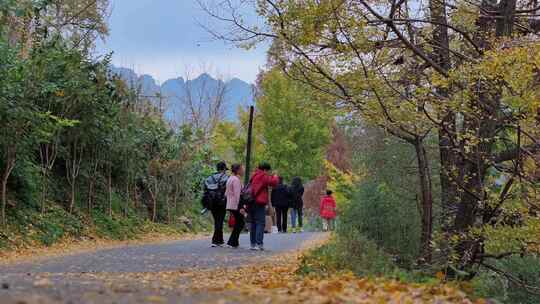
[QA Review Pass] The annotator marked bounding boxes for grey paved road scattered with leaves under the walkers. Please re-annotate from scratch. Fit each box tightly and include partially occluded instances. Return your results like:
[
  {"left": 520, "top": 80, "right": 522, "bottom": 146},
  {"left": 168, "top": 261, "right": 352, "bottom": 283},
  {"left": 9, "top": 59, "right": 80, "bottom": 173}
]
[{"left": 0, "top": 233, "right": 320, "bottom": 304}]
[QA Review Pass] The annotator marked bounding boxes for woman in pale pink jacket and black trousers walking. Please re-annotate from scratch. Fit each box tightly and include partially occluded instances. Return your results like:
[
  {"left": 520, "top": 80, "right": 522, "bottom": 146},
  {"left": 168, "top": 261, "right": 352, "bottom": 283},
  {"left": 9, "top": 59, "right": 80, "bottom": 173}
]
[{"left": 225, "top": 164, "right": 246, "bottom": 248}]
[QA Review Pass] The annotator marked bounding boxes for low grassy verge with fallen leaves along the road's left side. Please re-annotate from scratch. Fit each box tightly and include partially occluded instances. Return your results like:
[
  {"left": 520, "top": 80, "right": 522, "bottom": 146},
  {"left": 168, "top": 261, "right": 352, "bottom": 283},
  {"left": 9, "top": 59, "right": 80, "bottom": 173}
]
[{"left": 0, "top": 207, "right": 209, "bottom": 264}]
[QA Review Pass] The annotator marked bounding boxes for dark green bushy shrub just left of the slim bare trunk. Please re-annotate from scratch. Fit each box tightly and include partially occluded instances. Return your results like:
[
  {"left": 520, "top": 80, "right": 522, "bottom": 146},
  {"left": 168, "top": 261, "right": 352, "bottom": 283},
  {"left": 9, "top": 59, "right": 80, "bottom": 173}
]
[{"left": 341, "top": 128, "right": 436, "bottom": 266}]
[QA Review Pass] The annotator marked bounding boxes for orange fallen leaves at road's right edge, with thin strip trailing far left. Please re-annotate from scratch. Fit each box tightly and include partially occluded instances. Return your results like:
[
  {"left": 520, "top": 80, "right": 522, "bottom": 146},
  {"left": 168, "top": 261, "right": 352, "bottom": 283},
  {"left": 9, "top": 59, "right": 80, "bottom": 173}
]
[{"left": 77, "top": 239, "right": 486, "bottom": 303}]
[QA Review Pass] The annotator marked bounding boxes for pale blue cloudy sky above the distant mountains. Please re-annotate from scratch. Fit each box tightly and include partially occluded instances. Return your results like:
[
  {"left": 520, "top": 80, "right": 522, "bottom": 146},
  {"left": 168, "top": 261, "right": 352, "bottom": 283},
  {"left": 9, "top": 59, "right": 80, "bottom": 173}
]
[{"left": 97, "top": 0, "right": 266, "bottom": 82}]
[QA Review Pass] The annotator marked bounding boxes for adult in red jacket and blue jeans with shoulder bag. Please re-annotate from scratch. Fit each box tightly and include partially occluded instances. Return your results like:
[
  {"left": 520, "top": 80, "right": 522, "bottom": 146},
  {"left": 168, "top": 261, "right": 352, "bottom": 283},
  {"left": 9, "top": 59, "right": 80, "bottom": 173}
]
[{"left": 248, "top": 162, "right": 278, "bottom": 250}]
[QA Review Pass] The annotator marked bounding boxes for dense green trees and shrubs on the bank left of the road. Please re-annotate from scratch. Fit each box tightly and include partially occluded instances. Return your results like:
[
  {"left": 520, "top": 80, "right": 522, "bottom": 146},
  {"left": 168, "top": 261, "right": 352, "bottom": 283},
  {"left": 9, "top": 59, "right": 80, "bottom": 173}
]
[{"left": 0, "top": 8, "right": 213, "bottom": 247}]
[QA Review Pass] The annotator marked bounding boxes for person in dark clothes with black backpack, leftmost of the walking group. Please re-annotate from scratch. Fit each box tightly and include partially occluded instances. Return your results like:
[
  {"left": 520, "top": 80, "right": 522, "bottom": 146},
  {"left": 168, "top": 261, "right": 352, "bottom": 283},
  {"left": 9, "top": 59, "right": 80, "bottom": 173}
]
[{"left": 202, "top": 162, "right": 229, "bottom": 247}]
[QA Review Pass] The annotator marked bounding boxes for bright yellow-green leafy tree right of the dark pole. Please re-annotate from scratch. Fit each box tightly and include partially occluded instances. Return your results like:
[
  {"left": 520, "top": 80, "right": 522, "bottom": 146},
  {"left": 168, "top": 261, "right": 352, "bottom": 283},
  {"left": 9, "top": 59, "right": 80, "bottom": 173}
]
[{"left": 257, "top": 69, "right": 334, "bottom": 180}]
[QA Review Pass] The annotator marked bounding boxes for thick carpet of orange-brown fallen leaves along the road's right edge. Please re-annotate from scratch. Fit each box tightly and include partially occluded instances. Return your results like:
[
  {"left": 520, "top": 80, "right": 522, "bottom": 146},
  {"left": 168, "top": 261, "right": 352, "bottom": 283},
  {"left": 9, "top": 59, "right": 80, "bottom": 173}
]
[{"left": 185, "top": 256, "right": 485, "bottom": 303}]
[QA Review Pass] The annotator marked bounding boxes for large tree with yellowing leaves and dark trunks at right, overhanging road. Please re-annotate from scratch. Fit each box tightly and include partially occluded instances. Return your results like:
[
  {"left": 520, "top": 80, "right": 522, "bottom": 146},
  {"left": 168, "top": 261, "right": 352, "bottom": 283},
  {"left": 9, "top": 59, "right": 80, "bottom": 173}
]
[{"left": 202, "top": 0, "right": 540, "bottom": 278}]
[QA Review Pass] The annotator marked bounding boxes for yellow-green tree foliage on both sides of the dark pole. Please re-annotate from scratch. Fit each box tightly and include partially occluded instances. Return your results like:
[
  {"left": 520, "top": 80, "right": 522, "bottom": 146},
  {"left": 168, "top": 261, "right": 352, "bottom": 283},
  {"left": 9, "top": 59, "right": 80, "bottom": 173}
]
[{"left": 212, "top": 69, "right": 335, "bottom": 180}]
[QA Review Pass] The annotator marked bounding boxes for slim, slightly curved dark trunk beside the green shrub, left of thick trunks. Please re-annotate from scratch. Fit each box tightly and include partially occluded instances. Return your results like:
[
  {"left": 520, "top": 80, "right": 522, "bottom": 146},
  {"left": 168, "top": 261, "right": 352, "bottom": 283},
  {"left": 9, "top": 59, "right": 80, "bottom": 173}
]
[{"left": 414, "top": 138, "right": 433, "bottom": 263}]
